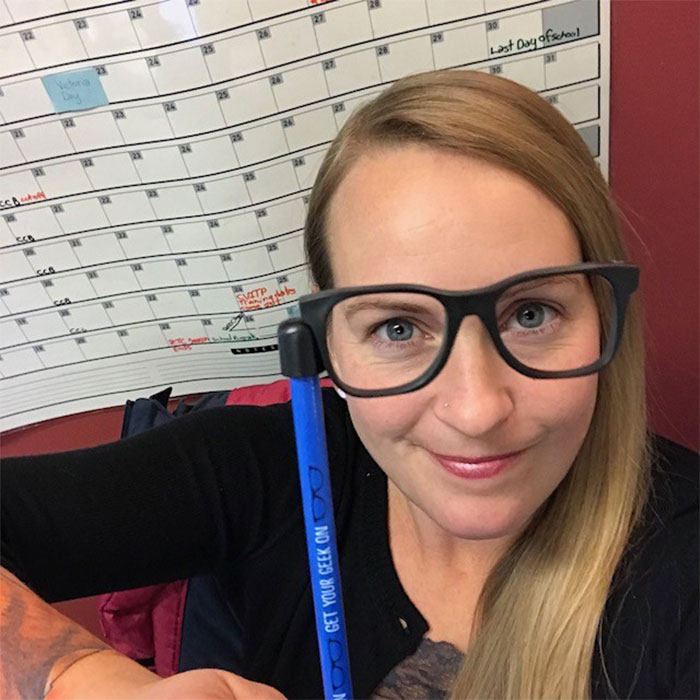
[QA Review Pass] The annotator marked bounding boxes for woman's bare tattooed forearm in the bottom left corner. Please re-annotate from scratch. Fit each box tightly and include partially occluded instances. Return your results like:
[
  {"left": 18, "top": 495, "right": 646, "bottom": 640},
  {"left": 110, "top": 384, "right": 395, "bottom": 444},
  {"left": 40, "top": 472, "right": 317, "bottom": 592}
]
[{"left": 0, "top": 567, "right": 158, "bottom": 700}]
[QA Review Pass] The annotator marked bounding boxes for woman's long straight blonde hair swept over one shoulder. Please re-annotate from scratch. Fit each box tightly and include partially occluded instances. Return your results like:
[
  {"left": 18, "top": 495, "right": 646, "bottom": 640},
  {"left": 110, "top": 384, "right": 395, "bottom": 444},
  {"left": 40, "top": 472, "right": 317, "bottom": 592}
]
[{"left": 305, "top": 70, "right": 651, "bottom": 700}]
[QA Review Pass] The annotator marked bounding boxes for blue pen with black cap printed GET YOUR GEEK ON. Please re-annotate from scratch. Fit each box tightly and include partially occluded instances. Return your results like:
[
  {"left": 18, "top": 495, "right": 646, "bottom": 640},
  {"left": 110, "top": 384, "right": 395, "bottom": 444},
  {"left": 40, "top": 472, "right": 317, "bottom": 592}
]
[{"left": 277, "top": 319, "right": 353, "bottom": 700}]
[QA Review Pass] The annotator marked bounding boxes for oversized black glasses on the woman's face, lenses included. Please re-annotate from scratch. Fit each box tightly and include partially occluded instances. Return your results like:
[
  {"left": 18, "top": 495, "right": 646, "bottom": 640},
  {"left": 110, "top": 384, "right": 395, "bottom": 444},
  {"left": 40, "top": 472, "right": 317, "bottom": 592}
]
[{"left": 299, "top": 262, "right": 639, "bottom": 397}]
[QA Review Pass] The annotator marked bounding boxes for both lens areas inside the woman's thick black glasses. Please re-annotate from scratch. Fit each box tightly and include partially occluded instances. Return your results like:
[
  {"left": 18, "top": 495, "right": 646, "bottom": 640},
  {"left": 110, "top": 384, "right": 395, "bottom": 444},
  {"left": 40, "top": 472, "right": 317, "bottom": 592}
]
[{"left": 326, "top": 273, "right": 615, "bottom": 391}]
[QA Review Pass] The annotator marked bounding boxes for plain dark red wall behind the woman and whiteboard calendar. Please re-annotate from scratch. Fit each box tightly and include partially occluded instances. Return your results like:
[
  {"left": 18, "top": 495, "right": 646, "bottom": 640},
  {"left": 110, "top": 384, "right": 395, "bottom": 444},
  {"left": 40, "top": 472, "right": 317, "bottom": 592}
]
[{"left": 1, "top": 0, "right": 700, "bottom": 644}]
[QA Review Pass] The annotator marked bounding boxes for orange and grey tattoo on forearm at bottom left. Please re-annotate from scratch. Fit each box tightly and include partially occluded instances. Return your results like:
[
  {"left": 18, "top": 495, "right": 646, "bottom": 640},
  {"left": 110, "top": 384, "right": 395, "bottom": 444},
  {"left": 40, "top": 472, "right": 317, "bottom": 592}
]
[{"left": 0, "top": 568, "right": 112, "bottom": 700}]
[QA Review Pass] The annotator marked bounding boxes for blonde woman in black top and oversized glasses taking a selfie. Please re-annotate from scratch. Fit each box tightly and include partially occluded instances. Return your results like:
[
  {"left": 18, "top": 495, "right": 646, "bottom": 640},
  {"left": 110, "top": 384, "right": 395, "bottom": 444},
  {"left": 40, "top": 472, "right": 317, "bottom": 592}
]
[{"left": 3, "top": 71, "right": 697, "bottom": 699}]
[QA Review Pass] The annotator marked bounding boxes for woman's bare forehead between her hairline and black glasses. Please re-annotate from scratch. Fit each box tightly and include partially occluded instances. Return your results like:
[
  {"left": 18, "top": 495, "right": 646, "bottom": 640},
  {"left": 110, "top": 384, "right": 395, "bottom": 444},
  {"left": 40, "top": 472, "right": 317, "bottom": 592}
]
[{"left": 326, "top": 145, "right": 580, "bottom": 289}]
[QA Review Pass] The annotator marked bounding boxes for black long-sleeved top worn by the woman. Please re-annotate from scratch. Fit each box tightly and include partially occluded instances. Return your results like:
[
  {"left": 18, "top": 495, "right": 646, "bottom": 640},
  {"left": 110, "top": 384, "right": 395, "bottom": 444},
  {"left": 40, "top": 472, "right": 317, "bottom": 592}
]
[{"left": 0, "top": 389, "right": 700, "bottom": 698}]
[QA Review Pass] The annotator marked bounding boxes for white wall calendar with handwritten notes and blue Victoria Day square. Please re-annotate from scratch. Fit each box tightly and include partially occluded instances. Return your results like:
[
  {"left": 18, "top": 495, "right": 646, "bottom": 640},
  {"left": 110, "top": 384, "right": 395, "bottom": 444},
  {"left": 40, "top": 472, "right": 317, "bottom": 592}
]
[{"left": 0, "top": 0, "right": 610, "bottom": 430}]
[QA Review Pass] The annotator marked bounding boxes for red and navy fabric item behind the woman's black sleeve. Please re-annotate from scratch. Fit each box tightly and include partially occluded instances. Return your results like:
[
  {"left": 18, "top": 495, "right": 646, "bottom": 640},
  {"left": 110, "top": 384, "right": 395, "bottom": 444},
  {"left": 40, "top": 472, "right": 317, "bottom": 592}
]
[{"left": 98, "top": 379, "right": 333, "bottom": 678}]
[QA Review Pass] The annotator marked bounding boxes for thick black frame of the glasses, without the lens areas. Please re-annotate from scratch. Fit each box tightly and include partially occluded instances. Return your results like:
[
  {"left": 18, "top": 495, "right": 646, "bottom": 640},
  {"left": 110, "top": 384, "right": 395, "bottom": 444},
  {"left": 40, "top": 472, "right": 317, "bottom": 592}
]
[{"left": 299, "top": 261, "right": 639, "bottom": 398}]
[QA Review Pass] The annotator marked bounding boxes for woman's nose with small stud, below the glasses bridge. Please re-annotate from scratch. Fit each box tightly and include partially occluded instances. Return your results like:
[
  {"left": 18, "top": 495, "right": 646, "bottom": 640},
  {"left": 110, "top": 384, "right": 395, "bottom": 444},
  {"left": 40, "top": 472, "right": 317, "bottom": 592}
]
[{"left": 433, "top": 316, "right": 516, "bottom": 438}]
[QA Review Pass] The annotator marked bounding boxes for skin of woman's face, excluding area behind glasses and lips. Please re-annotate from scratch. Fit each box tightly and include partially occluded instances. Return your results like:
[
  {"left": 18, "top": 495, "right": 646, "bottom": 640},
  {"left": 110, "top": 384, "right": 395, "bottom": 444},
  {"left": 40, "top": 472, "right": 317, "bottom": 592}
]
[{"left": 327, "top": 145, "right": 597, "bottom": 540}]
